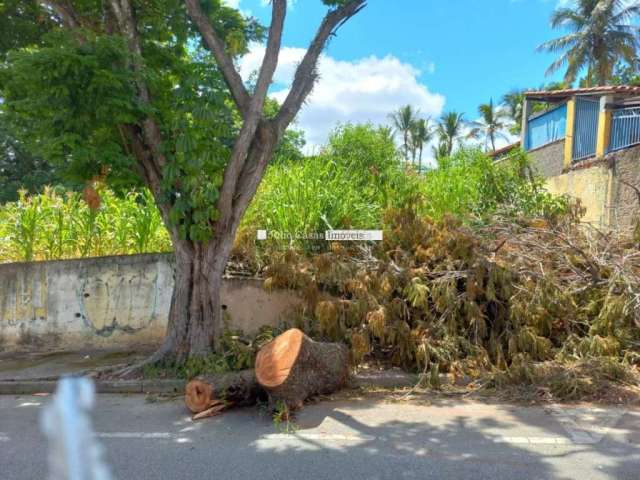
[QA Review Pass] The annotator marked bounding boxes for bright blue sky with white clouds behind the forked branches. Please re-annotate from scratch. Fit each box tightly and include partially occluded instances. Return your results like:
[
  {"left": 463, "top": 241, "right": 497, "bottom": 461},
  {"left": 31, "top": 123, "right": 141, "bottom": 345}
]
[{"left": 227, "top": 0, "right": 560, "bottom": 152}]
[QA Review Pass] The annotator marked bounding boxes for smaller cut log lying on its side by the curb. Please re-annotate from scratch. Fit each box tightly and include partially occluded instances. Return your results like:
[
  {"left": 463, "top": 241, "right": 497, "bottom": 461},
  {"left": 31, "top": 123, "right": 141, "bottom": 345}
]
[{"left": 184, "top": 370, "right": 266, "bottom": 413}]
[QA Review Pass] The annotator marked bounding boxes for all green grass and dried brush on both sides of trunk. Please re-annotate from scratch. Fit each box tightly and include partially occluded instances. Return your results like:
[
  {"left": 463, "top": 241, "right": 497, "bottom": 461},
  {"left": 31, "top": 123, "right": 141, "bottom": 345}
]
[{"left": 0, "top": 125, "right": 640, "bottom": 399}]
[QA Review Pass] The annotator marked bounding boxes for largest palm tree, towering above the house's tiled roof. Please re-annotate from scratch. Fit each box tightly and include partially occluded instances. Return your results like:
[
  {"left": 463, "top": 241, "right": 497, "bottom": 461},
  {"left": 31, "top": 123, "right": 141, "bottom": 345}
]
[{"left": 538, "top": 0, "right": 640, "bottom": 85}]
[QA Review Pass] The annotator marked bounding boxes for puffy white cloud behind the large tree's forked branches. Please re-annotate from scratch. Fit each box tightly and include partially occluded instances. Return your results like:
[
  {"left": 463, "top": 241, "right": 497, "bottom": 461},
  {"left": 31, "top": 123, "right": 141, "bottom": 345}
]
[{"left": 240, "top": 44, "right": 445, "bottom": 152}]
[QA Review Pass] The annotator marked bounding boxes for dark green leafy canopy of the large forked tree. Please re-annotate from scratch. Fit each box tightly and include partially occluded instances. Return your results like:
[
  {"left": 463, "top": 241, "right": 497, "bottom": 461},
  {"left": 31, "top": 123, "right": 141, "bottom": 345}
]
[{"left": 0, "top": 0, "right": 264, "bottom": 239}]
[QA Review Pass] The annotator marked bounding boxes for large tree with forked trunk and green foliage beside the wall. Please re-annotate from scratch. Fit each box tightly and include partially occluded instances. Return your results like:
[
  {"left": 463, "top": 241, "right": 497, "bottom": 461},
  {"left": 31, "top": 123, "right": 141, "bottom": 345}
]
[{"left": 0, "top": 0, "right": 365, "bottom": 362}]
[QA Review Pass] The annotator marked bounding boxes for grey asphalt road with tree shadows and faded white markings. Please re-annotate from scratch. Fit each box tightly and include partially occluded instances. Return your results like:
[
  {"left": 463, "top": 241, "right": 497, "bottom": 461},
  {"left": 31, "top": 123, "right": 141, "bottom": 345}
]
[{"left": 0, "top": 395, "right": 640, "bottom": 480}]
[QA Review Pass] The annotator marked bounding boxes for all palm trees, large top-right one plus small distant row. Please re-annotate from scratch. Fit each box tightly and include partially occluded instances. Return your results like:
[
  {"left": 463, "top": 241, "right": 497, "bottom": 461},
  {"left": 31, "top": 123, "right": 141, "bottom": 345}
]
[{"left": 390, "top": 0, "right": 640, "bottom": 163}]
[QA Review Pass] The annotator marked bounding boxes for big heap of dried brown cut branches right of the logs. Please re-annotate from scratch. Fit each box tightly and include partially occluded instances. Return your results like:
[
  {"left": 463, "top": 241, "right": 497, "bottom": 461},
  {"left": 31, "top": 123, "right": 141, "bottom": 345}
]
[{"left": 265, "top": 209, "right": 640, "bottom": 398}]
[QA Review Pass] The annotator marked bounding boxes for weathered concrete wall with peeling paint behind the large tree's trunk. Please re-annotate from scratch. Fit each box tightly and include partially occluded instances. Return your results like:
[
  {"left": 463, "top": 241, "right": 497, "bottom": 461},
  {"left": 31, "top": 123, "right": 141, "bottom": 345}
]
[{"left": 0, "top": 254, "right": 299, "bottom": 350}]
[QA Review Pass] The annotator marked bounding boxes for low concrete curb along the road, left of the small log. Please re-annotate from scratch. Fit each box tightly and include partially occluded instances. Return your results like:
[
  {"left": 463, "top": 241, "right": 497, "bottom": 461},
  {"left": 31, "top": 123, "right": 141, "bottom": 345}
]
[{"left": 0, "top": 379, "right": 187, "bottom": 395}]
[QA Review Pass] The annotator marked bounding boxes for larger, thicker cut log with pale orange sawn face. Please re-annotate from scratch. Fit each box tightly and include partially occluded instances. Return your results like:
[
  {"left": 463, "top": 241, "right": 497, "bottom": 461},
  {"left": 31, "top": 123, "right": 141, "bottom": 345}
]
[{"left": 256, "top": 328, "right": 349, "bottom": 409}]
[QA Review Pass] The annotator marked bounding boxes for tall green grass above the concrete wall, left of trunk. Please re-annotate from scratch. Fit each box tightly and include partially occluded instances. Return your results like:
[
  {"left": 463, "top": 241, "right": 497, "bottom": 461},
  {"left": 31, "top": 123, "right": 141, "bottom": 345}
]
[{"left": 0, "top": 188, "right": 171, "bottom": 262}]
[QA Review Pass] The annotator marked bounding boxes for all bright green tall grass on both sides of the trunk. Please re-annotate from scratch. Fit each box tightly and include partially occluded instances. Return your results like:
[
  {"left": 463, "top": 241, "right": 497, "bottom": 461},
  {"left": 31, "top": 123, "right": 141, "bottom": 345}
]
[{"left": 0, "top": 125, "right": 565, "bottom": 262}]
